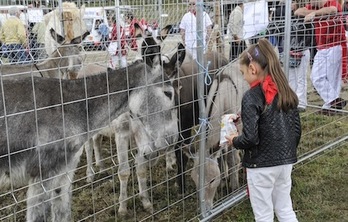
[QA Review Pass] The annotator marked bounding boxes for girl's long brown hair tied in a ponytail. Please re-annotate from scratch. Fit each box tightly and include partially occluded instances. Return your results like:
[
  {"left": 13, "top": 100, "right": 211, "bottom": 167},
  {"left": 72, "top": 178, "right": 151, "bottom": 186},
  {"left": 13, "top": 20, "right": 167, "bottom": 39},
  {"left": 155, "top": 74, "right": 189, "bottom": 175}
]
[{"left": 239, "top": 38, "right": 298, "bottom": 111}]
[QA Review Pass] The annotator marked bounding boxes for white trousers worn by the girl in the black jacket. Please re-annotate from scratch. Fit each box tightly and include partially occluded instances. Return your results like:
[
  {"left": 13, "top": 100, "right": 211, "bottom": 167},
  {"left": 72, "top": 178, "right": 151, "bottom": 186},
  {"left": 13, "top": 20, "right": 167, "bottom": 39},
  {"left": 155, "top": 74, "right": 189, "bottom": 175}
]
[{"left": 247, "top": 164, "right": 298, "bottom": 222}]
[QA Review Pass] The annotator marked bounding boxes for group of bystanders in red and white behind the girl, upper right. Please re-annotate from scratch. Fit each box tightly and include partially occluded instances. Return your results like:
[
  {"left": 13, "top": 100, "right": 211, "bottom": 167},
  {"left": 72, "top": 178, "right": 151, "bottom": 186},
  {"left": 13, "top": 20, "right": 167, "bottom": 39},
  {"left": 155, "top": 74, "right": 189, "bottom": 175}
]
[{"left": 228, "top": 0, "right": 348, "bottom": 115}]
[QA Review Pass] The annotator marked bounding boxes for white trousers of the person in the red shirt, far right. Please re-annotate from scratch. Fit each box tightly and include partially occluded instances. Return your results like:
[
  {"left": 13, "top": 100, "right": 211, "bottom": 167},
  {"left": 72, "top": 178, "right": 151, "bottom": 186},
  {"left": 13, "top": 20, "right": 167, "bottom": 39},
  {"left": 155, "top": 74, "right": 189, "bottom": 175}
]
[{"left": 311, "top": 45, "right": 342, "bottom": 109}]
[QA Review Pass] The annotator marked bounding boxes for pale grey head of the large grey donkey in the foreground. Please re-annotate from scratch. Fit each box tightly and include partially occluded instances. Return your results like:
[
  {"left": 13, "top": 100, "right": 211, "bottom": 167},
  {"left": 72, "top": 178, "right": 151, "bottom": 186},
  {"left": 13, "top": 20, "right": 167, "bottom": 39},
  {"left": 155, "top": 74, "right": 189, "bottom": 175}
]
[{"left": 129, "top": 55, "right": 178, "bottom": 158}]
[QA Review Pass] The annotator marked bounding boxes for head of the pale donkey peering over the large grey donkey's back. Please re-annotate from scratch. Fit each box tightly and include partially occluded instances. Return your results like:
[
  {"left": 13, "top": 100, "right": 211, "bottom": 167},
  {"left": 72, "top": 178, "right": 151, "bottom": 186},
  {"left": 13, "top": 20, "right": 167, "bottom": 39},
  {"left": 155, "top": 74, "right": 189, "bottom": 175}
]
[{"left": 50, "top": 28, "right": 89, "bottom": 79}]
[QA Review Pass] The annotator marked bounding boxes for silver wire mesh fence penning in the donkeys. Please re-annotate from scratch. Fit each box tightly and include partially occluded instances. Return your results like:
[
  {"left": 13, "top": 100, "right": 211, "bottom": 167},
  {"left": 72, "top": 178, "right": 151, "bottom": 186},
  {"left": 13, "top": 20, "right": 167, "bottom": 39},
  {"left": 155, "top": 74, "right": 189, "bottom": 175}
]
[{"left": 0, "top": 0, "right": 348, "bottom": 221}]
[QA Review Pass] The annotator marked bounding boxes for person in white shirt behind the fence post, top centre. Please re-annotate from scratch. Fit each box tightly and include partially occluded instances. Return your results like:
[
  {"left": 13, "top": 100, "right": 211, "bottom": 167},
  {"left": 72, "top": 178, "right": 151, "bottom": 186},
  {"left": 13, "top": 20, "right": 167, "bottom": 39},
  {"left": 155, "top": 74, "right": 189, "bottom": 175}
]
[{"left": 179, "top": 0, "right": 213, "bottom": 59}]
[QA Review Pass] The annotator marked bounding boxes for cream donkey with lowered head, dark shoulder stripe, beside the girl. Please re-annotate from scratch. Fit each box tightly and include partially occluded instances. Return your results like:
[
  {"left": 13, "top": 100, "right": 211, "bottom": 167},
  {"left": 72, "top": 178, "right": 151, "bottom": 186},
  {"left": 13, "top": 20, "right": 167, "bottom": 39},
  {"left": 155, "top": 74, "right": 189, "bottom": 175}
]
[{"left": 190, "top": 60, "right": 249, "bottom": 210}]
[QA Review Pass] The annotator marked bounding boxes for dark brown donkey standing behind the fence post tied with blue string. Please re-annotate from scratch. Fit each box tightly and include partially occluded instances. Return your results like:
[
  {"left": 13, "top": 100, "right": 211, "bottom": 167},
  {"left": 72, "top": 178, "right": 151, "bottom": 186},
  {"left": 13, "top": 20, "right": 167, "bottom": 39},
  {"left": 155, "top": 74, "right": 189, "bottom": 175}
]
[{"left": 169, "top": 49, "right": 228, "bottom": 193}]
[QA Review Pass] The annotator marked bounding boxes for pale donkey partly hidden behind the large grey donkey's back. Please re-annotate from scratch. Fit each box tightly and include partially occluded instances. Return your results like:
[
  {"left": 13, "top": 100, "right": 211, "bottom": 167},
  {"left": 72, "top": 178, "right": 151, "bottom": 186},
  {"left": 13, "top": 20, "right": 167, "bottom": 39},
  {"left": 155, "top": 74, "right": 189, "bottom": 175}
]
[{"left": 0, "top": 29, "right": 89, "bottom": 79}]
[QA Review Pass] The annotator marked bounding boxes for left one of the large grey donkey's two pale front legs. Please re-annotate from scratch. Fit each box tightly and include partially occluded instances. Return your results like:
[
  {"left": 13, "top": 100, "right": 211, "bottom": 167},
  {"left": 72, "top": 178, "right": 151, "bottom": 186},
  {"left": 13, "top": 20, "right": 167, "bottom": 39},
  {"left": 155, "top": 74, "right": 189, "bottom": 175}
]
[{"left": 27, "top": 179, "right": 49, "bottom": 222}]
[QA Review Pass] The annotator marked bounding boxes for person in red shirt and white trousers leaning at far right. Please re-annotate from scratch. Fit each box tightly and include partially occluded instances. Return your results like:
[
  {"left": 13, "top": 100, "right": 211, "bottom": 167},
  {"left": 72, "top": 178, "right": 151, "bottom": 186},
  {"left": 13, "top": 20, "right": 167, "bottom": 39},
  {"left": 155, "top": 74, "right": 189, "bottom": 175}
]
[{"left": 295, "top": 0, "right": 347, "bottom": 112}]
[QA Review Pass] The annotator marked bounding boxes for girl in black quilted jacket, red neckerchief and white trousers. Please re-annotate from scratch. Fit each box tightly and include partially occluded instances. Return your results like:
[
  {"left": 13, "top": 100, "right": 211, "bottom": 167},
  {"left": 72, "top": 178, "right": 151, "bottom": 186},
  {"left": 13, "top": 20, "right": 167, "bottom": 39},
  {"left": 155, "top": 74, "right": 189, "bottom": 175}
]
[{"left": 226, "top": 39, "right": 301, "bottom": 222}]
